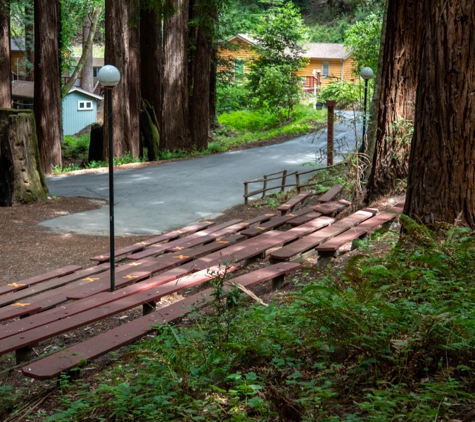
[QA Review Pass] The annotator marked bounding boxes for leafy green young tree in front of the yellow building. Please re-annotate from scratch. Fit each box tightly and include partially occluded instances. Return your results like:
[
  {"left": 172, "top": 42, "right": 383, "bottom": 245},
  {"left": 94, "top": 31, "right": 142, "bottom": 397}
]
[{"left": 247, "top": 2, "right": 308, "bottom": 119}]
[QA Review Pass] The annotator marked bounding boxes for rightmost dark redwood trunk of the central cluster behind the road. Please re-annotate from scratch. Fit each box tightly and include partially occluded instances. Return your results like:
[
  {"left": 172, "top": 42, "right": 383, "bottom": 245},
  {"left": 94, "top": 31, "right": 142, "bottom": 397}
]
[{"left": 189, "top": 0, "right": 217, "bottom": 151}]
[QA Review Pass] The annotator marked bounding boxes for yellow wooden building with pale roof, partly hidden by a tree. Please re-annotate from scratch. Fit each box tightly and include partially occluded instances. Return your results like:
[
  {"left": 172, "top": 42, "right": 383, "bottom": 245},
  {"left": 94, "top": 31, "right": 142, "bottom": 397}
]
[{"left": 219, "top": 34, "right": 357, "bottom": 91}]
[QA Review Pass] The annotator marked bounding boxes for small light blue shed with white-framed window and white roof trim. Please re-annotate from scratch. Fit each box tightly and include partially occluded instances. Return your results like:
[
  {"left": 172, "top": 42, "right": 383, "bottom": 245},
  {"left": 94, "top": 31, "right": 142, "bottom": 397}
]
[{"left": 63, "top": 86, "right": 102, "bottom": 135}]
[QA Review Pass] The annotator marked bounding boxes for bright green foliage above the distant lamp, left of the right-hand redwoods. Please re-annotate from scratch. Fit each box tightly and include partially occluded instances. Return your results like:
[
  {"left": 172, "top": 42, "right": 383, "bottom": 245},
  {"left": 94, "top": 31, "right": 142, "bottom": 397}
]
[{"left": 344, "top": 13, "right": 382, "bottom": 75}]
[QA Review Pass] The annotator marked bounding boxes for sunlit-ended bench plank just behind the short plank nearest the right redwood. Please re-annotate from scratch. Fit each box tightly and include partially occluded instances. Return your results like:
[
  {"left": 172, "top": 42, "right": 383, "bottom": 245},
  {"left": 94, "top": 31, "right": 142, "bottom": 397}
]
[{"left": 270, "top": 211, "right": 373, "bottom": 261}]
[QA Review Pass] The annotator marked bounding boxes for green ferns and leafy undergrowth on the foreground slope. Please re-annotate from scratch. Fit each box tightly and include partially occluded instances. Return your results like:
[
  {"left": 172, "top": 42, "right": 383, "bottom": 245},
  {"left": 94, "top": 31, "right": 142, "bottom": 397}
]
[{"left": 5, "top": 216, "right": 475, "bottom": 422}]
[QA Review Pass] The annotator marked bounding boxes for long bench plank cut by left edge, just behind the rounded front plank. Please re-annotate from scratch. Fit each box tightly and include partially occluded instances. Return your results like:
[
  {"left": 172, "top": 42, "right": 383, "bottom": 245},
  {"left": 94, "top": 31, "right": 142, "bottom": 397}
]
[{"left": 0, "top": 266, "right": 239, "bottom": 355}]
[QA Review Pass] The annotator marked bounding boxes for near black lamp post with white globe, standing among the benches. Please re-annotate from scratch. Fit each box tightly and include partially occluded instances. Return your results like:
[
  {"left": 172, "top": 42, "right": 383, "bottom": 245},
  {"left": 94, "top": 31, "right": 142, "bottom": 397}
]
[{"left": 97, "top": 64, "right": 120, "bottom": 292}]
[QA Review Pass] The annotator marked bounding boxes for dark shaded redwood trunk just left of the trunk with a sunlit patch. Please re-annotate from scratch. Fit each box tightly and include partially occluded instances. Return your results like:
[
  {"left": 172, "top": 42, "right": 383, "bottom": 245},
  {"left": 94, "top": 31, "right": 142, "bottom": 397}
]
[{"left": 140, "top": 6, "right": 163, "bottom": 145}]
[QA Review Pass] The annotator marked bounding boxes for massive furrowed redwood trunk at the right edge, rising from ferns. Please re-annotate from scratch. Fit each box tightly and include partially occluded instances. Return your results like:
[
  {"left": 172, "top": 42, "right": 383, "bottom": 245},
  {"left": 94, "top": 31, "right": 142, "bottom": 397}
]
[{"left": 404, "top": 0, "right": 475, "bottom": 229}]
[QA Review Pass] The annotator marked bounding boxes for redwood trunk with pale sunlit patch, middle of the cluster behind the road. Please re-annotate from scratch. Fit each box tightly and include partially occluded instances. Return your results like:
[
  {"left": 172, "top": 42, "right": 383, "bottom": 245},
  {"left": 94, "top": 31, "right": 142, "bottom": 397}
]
[{"left": 160, "top": 0, "right": 193, "bottom": 152}]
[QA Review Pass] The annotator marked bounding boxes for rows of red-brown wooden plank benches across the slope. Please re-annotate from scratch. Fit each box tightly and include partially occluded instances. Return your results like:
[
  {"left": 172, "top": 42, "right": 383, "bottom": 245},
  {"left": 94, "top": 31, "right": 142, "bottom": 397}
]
[{"left": 0, "top": 187, "right": 402, "bottom": 379}]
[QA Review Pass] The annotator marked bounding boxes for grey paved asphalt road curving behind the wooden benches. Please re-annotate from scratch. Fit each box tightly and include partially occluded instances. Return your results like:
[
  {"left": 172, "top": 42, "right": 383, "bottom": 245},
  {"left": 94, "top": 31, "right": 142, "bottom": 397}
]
[{"left": 40, "top": 110, "right": 355, "bottom": 235}]
